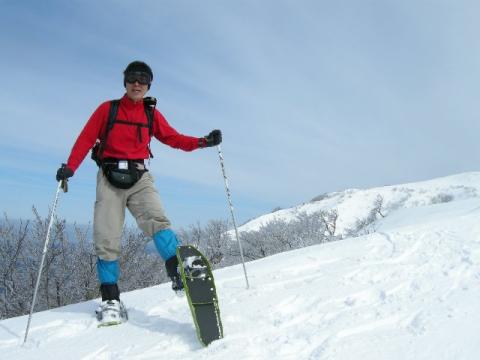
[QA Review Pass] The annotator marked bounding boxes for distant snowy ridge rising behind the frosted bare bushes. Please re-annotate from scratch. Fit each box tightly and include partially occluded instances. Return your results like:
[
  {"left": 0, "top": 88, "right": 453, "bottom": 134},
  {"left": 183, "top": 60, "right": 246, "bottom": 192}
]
[{"left": 239, "top": 172, "right": 480, "bottom": 237}]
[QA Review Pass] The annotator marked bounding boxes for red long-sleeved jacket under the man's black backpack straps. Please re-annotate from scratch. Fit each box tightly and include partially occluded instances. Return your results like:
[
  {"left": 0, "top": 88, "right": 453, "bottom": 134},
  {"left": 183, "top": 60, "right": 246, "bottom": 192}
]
[{"left": 67, "top": 95, "right": 199, "bottom": 171}]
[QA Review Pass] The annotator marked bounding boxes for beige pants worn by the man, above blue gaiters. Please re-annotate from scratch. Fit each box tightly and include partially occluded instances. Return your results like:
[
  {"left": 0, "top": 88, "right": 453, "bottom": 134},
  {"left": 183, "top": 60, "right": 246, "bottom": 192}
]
[{"left": 93, "top": 170, "right": 170, "bottom": 261}]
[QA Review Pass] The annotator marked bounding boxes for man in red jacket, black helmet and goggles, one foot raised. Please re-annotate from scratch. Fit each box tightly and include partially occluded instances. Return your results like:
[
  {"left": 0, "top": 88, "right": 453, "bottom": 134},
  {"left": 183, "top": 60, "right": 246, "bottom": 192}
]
[{"left": 56, "top": 61, "right": 222, "bottom": 324}]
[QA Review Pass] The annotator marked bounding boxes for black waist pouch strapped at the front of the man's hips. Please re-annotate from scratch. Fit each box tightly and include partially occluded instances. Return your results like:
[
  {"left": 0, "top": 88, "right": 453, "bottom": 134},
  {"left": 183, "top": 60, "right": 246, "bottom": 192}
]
[{"left": 102, "top": 159, "right": 147, "bottom": 189}]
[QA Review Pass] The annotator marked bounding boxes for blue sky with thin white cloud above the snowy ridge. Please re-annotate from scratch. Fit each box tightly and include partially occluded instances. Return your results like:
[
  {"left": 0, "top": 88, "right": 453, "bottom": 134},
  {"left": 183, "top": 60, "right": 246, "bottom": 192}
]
[{"left": 0, "top": 0, "right": 480, "bottom": 227}]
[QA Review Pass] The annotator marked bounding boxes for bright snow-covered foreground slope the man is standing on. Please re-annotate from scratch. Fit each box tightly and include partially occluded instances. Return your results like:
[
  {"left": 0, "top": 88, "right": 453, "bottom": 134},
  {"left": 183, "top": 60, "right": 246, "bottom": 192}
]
[{"left": 0, "top": 174, "right": 480, "bottom": 360}]
